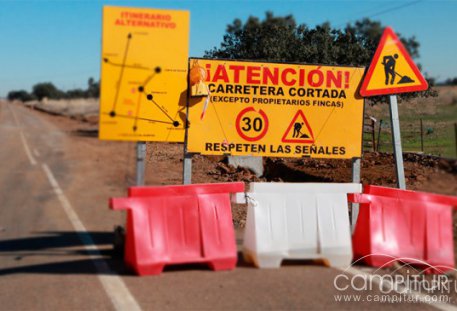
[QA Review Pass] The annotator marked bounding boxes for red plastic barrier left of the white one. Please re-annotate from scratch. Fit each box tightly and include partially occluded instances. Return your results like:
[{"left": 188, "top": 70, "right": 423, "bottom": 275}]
[{"left": 110, "top": 183, "right": 244, "bottom": 275}]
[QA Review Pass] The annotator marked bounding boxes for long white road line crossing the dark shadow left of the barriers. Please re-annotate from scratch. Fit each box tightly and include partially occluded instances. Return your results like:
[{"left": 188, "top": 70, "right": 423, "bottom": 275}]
[{"left": 42, "top": 163, "right": 141, "bottom": 311}]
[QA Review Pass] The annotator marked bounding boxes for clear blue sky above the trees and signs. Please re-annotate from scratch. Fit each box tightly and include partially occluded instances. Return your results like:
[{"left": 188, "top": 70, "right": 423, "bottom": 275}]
[{"left": 0, "top": 0, "right": 457, "bottom": 97}]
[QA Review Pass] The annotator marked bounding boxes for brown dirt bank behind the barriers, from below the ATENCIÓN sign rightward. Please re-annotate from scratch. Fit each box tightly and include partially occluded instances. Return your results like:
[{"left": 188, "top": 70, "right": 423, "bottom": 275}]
[{"left": 194, "top": 152, "right": 457, "bottom": 194}]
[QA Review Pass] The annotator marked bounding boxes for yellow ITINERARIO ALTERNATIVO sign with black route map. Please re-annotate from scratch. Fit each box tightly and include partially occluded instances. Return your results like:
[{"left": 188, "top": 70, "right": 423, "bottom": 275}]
[{"left": 99, "top": 6, "right": 189, "bottom": 142}]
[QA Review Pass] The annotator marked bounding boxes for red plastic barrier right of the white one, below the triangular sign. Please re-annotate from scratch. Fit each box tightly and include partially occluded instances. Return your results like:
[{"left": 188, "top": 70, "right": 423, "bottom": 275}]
[{"left": 349, "top": 186, "right": 457, "bottom": 272}]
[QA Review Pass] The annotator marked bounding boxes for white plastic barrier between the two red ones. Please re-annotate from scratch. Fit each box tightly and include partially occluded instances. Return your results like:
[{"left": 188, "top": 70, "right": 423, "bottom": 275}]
[{"left": 236, "top": 183, "right": 362, "bottom": 268}]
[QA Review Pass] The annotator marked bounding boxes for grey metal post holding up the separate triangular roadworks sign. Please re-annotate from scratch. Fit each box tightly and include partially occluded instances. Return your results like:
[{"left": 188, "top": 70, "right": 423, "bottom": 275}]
[{"left": 389, "top": 95, "right": 406, "bottom": 189}]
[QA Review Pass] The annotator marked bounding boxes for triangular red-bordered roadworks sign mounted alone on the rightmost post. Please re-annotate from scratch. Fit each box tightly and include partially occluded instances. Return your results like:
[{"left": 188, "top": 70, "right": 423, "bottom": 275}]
[{"left": 360, "top": 27, "right": 428, "bottom": 97}]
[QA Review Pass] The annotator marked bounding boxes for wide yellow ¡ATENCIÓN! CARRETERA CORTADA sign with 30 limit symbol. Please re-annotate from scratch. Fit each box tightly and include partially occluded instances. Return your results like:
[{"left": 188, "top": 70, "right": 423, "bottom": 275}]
[{"left": 187, "top": 59, "right": 364, "bottom": 158}]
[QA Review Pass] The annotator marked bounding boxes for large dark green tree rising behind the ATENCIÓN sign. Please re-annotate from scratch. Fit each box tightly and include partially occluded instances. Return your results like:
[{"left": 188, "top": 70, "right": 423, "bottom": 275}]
[{"left": 205, "top": 12, "right": 436, "bottom": 102}]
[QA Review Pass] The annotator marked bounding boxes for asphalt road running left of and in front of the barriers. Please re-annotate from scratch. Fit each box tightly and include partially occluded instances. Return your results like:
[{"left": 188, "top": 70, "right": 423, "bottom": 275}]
[{"left": 0, "top": 102, "right": 450, "bottom": 310}]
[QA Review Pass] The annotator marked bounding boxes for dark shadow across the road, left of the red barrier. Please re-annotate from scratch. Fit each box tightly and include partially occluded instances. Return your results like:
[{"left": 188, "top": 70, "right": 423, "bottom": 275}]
[{"left": 0, "top": 232, "right": 131, "bottom": 276}]
